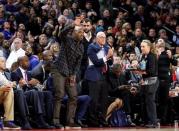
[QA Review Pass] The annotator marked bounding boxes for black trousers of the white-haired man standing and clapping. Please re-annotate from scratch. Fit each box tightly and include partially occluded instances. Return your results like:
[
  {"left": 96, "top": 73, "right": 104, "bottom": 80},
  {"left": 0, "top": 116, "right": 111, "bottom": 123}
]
[{"left": 88, "top": 80, "right": 108, "bottom": 125}]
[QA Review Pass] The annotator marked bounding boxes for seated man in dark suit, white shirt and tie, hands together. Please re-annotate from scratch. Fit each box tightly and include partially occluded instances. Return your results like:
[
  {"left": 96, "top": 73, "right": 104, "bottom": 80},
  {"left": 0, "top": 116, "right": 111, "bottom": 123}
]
[{"left": 11, "top": 56, "right": 52, "bottom": 128}]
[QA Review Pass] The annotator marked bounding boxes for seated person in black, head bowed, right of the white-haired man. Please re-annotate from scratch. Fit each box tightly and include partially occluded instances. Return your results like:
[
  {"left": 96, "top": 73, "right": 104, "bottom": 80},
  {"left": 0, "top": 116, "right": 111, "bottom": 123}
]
[{"left": 109, "top": 64, "right": 138, "bottom": 126}]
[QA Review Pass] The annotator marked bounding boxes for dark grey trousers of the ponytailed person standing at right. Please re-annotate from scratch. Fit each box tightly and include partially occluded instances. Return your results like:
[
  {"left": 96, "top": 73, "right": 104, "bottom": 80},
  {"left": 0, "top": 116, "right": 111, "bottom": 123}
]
[{"left": 142, "top": 80, "right": 159, "bottom": 124}]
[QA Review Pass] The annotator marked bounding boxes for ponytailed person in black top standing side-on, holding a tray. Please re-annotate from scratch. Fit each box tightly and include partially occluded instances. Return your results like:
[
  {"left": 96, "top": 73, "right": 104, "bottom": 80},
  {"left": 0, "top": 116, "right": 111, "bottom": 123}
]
[{"left": 134, "top": 40, "right": 159, "bottom": 128}]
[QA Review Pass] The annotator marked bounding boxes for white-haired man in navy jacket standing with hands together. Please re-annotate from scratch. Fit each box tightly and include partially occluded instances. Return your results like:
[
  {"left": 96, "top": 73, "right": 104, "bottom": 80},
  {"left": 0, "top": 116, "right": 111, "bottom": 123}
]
[{"left": 85, "top": 32, "right": 113, "bottom": 126}]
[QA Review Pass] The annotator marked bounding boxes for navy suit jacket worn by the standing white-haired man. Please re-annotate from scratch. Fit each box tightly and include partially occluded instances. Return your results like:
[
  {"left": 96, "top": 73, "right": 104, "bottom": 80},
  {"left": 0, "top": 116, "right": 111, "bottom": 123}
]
[{"left": 85, "top": 43, "right": 112, "bottom": 81}]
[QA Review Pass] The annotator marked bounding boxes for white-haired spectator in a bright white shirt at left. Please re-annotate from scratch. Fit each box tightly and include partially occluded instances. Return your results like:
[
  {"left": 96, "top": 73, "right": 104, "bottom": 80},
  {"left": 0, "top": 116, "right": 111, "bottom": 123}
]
[{"left": 6, "top": 38, "right": 25, "bottom": 69}]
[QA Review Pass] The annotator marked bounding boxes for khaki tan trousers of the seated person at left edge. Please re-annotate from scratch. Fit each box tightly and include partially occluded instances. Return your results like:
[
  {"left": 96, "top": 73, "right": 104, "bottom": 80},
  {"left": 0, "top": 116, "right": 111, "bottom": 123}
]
[{"left": 0, "top": 88, "right": 14, "bottom": 121}]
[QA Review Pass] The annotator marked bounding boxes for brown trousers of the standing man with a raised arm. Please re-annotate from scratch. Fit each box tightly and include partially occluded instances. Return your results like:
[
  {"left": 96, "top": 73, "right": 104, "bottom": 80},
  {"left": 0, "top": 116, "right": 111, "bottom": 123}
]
[{"left": 51, "top": 68, "right": 77, "bottom": 124}]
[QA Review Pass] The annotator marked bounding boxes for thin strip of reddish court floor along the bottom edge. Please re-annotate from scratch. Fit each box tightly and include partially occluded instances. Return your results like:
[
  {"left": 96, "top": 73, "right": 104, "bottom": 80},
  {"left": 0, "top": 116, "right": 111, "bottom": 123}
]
[{"left": 23, "top": 127, "right": 179, "bottom": 131}]
